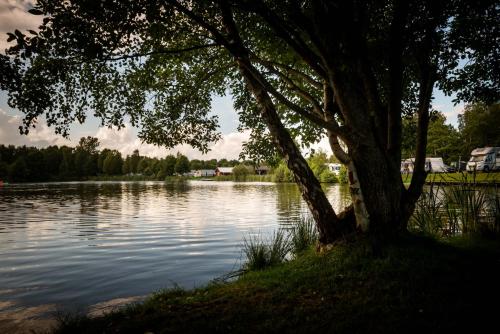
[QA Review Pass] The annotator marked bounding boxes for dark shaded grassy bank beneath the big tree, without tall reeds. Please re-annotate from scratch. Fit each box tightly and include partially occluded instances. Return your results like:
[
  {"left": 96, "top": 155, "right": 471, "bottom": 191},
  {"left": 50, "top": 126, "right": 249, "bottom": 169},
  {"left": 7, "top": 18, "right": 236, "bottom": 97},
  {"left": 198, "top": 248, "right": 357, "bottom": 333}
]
[{"left": 56, "top": 236, "right": 500, "bottom": 333}]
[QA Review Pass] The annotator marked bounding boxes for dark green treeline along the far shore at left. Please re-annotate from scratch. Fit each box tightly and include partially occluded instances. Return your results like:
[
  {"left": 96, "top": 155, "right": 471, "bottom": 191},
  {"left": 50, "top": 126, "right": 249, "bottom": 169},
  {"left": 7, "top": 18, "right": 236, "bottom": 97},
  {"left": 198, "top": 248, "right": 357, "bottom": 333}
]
[{"left": 0, "top": 137, "right": 240, "bottom": 182}]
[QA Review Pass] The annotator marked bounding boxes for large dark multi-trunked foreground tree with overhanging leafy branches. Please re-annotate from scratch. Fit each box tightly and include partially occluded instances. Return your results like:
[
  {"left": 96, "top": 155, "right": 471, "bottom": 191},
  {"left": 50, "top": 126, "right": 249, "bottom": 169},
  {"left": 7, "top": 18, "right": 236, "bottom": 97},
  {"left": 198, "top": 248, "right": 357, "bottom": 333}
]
[{"left": 0, "top": 0, "right": 500, "bottom": 242}]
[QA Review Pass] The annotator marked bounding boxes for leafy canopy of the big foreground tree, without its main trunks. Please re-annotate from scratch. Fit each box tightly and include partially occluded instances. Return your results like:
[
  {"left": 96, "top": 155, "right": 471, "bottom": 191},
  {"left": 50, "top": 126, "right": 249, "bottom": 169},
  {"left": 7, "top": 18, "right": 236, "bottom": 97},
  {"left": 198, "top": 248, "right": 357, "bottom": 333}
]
[{"left": 0, "top": 0, "right": 500, "bottom": 160}]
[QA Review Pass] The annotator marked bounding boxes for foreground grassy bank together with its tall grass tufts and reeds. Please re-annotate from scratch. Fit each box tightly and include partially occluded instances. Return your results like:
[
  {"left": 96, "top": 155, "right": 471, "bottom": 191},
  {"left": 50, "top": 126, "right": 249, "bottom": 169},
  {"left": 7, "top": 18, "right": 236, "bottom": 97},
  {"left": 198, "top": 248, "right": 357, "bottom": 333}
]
[{"left": 55, "top": 180, "right": 500, "bottom": 333}]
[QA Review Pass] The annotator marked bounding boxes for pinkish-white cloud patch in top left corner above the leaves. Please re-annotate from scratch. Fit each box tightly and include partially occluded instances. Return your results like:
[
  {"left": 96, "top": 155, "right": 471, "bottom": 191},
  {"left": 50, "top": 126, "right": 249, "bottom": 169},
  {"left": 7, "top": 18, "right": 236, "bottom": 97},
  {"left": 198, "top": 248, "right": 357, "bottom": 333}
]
[{"left": 0, "top": 0, "right": 42, "bottom": 53}]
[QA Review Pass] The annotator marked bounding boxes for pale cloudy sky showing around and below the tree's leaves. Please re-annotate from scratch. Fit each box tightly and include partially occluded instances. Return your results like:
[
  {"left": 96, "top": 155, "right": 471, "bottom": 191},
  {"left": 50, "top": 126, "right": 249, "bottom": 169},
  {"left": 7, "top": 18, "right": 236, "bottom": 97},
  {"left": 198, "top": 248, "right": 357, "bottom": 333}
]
[{"left": 0, "top": 0, "right": 464, "bottom": 160}]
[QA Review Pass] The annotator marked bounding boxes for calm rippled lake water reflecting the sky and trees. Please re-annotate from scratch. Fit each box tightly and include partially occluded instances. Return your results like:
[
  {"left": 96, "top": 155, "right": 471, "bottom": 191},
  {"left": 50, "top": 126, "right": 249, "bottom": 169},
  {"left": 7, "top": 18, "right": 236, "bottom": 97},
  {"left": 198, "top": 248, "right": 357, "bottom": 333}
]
[{"left": 0, "top": 181, "right": 348, "bottom": 312}]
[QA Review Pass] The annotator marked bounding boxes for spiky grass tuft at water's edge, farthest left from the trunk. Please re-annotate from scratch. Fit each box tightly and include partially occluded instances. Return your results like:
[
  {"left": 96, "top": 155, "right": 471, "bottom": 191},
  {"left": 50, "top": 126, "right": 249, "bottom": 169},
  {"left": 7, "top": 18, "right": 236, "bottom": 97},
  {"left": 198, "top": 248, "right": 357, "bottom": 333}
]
[{"left": 243, "top": 230, "right": 290, "bottom": 270}]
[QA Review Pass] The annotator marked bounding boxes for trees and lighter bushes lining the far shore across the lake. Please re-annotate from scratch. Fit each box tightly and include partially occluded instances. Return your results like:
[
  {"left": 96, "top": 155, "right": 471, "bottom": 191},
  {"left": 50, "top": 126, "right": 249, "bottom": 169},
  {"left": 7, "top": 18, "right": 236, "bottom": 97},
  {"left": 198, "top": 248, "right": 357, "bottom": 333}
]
[{"left": 0, "top": 137, "right": 347, "bottom": 183}]
